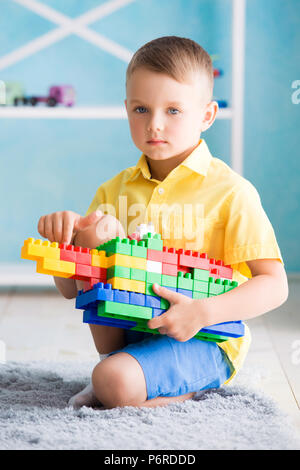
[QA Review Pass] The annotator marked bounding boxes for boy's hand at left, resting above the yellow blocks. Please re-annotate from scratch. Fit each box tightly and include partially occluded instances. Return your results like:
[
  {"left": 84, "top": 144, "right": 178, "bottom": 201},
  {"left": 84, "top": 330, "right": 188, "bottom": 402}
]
[{"left": 38, "top": 210, "right": 104, "bottom": 244}]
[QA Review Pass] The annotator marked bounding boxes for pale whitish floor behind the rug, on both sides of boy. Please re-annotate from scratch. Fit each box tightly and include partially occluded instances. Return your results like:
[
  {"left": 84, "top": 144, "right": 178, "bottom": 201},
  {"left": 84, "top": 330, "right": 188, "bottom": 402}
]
[{"left": 0, "top": 279, "right": 300, "bottom": 430}]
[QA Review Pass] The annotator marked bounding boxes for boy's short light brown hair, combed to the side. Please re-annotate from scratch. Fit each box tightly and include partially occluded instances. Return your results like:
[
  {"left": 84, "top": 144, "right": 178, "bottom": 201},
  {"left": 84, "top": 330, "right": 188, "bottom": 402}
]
[{"left": 126, "top": 36, "right": 214, "bottom": 100}]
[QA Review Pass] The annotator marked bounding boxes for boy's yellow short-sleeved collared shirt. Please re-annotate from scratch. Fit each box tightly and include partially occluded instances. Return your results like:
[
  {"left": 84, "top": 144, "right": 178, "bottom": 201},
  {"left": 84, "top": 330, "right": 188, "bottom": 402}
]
[{"left": 86, "top": 139, "right": 283, "bottom": 383}]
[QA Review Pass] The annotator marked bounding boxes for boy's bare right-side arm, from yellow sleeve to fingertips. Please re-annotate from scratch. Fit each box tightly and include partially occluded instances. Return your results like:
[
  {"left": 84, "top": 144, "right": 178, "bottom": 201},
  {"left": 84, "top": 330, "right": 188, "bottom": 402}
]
[{"left": 148, "top": 259, "right": 288, "bottom": 341}]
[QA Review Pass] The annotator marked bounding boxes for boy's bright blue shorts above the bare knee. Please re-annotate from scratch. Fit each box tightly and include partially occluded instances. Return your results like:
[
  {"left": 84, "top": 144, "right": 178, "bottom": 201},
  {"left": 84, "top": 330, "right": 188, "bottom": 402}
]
[{"left": 109, "top": 330, "right": 234, "bottom": 400}]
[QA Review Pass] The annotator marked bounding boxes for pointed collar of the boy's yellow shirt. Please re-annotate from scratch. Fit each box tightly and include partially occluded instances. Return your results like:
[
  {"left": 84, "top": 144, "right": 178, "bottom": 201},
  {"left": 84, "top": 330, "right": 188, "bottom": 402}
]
[{"left": 128, "top": 139, "right": 212, "bottom": 181}]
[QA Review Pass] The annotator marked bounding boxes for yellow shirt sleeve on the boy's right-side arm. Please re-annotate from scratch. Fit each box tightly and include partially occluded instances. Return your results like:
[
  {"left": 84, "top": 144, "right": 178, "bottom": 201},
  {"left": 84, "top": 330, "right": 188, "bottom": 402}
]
[{"left": 224, "top": 180, "right": 284, "bottom": 278}]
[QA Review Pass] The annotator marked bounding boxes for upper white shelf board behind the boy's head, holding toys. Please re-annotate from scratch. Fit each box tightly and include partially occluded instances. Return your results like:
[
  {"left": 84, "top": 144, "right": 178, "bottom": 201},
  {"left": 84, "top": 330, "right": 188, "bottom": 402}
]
[{"left": 0, "top": 106, "right": 232, "bottom": 119}]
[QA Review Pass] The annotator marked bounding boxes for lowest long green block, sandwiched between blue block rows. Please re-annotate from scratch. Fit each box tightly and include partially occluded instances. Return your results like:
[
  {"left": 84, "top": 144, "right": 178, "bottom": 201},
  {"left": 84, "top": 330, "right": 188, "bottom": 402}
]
[{"left": 98, "top": 300, "right": 152, "bottom": 320}]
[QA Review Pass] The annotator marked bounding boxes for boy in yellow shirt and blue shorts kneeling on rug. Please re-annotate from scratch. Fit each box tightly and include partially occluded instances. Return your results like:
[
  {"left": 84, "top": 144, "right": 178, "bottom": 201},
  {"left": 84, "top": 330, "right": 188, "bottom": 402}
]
[{"left": 38, "top": 36, "right": 288, "bottom": 408}]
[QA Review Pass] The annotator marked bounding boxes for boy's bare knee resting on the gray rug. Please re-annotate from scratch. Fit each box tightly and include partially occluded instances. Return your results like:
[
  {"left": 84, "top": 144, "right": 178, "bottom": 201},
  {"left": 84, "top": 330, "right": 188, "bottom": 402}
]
[{"left": 92, "top": 352, "right": 147, "bottom": 408}]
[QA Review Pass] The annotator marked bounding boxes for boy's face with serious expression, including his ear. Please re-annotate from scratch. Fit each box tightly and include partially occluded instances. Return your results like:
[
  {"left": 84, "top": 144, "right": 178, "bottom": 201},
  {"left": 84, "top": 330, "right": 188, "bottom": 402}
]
[{"left": 125, "top": 68, "right": 216, "bottom": 160}]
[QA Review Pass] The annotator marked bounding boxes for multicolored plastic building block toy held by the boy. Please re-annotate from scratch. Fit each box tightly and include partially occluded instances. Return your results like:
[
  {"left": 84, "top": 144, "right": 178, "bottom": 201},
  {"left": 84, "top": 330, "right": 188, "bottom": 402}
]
[{"left": 21, "top": 224, "right": 244, "bottom": 342}]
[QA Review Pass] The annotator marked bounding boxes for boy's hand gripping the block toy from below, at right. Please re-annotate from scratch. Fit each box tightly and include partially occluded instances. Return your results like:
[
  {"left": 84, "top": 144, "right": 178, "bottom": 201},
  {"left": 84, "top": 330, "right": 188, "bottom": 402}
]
[{"left": 148, "top": 284, "right": 207, "bottom": 342}]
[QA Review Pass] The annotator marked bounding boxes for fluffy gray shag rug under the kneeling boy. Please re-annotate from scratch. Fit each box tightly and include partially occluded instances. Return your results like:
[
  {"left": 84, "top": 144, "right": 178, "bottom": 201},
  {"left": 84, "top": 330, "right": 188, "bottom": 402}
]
[{"left": 0, "top": 361, "right": 300, "bottom": 450}]
